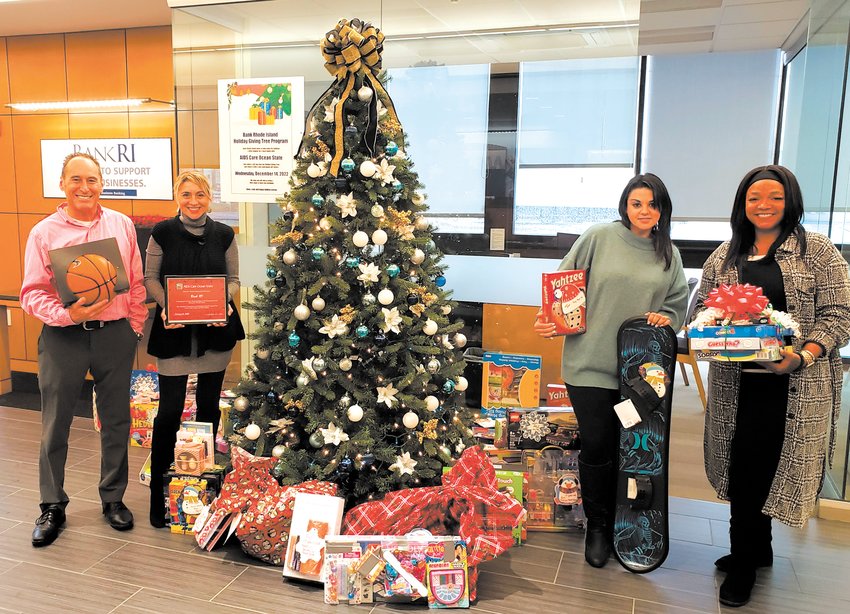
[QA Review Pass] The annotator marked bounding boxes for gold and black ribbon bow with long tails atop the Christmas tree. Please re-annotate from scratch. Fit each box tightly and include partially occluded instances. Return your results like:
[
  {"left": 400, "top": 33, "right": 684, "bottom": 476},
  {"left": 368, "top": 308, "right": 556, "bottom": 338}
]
[{"left": 321, "top": 18, "right": 398, "bottom": 177}]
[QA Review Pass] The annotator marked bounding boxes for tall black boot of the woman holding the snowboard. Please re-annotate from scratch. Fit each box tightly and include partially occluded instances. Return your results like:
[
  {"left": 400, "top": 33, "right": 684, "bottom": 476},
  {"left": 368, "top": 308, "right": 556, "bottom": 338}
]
[{"left": 578, "top": 460, "right": 614, "bottom": 567}]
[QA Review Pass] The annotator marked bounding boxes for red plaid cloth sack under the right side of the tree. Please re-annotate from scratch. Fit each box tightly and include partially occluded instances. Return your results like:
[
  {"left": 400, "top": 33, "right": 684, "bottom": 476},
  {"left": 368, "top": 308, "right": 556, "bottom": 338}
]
[{"left": 342, "top": 447, "right": 525, "bottom": 567}]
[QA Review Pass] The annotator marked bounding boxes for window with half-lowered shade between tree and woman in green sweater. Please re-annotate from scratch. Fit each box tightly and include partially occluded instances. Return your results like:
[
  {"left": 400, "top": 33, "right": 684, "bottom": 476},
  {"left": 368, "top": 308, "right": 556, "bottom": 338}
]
[{"left": 514, "top": 57, "right": 638, "bottom": 236}]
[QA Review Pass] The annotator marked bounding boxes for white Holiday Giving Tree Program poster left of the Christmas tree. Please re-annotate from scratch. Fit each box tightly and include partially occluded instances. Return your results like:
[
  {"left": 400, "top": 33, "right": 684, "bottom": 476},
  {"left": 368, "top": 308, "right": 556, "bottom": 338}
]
[{"left": 218, "top": 77, "right": 304, "bottom": 203}]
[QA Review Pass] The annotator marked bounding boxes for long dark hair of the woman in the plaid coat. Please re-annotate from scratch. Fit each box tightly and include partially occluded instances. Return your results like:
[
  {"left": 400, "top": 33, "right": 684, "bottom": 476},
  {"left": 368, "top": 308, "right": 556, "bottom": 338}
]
[{"left": 723, "top": 164, "right": 806, "bottom": 268}]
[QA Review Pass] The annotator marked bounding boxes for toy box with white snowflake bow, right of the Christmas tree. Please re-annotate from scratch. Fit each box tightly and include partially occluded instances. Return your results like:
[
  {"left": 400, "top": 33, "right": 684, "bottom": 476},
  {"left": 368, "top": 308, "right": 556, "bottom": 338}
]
[{"left": 508, "top": 407, "right": 581, "bottom": 450}]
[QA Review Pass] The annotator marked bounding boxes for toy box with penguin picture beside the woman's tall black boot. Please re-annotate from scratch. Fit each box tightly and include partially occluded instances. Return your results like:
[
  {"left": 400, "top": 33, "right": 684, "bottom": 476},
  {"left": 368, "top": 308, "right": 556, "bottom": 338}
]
[{"left": 523, "top": 447, "right": 585, "bottom": 531}]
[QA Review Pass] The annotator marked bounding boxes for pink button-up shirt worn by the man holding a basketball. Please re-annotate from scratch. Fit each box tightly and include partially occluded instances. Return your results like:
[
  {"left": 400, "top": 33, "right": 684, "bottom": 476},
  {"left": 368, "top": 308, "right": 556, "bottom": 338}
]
[{"left": 21, "top": 203, "right": 148, "bottom": 333}]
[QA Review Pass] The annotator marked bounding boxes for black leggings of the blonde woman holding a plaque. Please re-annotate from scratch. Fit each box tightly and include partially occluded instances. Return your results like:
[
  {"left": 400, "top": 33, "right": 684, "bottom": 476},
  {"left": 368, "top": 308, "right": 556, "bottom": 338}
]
[{"left": 151, "top": 371, "right": 224, "bottom": 515}]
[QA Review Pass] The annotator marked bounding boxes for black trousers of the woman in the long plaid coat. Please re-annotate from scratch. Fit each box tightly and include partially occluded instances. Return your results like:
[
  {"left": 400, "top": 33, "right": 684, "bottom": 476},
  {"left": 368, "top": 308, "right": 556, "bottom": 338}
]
[{"left": 729, "top": 373, "right": 789, "bottom": 566}]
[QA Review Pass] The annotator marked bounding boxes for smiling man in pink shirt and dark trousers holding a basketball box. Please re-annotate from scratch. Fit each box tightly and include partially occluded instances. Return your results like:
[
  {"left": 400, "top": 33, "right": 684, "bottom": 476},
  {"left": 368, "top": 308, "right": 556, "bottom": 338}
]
[{"left": 21, "top": 153, "right": 147, "bottom": 546}]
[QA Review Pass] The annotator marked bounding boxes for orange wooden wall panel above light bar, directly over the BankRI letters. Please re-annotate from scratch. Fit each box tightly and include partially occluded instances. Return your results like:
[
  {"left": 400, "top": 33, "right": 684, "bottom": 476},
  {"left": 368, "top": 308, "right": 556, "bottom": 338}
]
[{"left": 65, "top": 30, "right": 127, "bottom": 100}]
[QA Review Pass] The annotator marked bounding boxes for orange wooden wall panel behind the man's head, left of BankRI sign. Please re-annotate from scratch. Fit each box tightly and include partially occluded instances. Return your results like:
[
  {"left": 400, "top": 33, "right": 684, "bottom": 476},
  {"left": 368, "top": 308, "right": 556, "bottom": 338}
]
[{"left": 12, "top": 113, "right": 68, "bottom": 213}]
